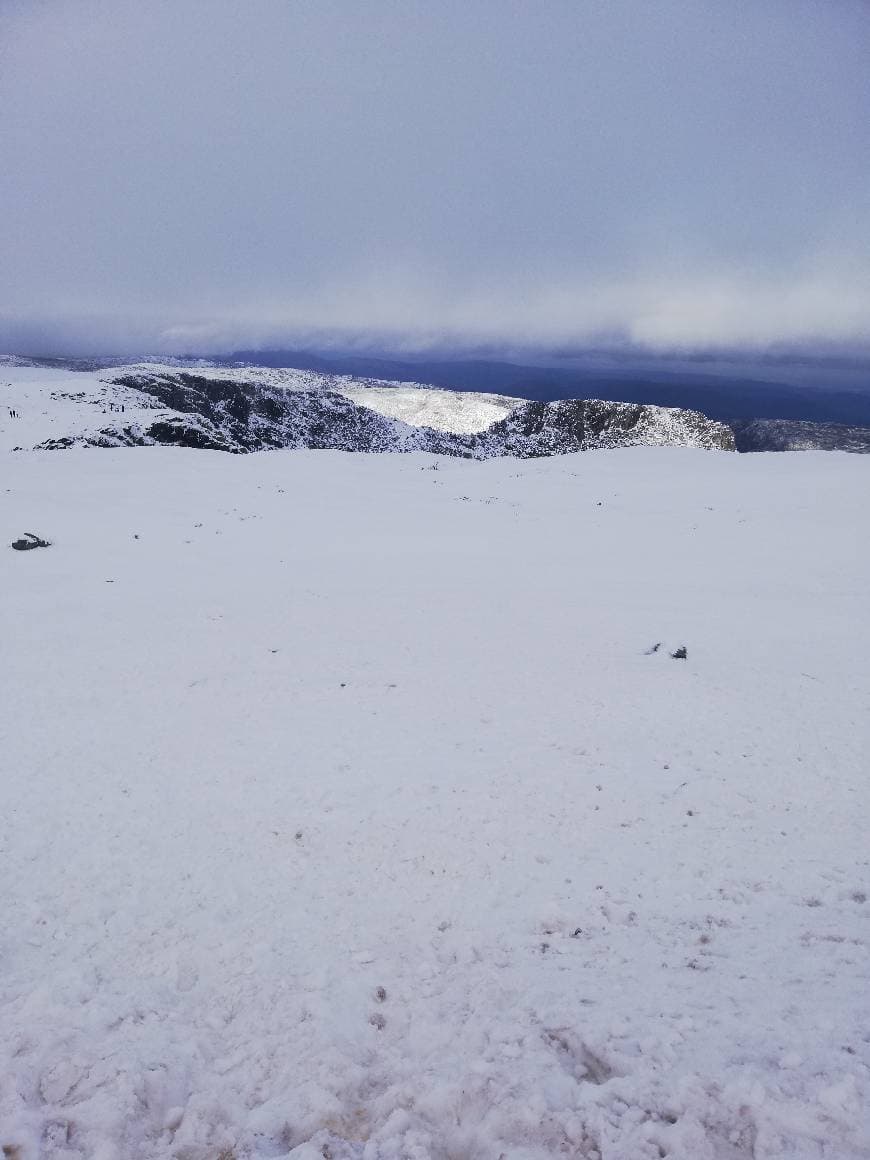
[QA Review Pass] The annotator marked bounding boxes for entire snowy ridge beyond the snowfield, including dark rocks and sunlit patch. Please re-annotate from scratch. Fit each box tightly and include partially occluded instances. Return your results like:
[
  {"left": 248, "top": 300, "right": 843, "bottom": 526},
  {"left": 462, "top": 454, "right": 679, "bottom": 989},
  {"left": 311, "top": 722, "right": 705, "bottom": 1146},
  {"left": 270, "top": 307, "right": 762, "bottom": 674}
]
[{"left": 0, "top": 363, "right": 734, "bottom": 459}]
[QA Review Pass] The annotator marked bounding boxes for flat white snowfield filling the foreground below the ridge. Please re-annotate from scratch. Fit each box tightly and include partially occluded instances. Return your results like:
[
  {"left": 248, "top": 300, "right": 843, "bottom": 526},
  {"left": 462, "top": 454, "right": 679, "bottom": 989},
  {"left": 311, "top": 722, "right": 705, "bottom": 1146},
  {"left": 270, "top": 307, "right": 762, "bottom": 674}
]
[{"left": 0, "top": 438, "right": 870, "bottom": 1160}]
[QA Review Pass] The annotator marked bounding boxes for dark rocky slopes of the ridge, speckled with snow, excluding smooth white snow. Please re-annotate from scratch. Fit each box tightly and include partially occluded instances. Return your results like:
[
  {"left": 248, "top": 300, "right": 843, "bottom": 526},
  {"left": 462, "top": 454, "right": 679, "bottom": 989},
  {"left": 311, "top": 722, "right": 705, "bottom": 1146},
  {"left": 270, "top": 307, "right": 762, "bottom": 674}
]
[{"left": 27, "top": 369, "right": 734, "bottom": 459}]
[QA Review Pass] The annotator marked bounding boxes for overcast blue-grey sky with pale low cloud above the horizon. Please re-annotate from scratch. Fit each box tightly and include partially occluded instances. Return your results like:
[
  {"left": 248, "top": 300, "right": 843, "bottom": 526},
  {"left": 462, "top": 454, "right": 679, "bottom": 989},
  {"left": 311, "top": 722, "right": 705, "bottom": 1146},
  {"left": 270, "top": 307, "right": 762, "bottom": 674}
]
[{"left": 0, "top": 0, "right": 870, "bottom": 351}]
